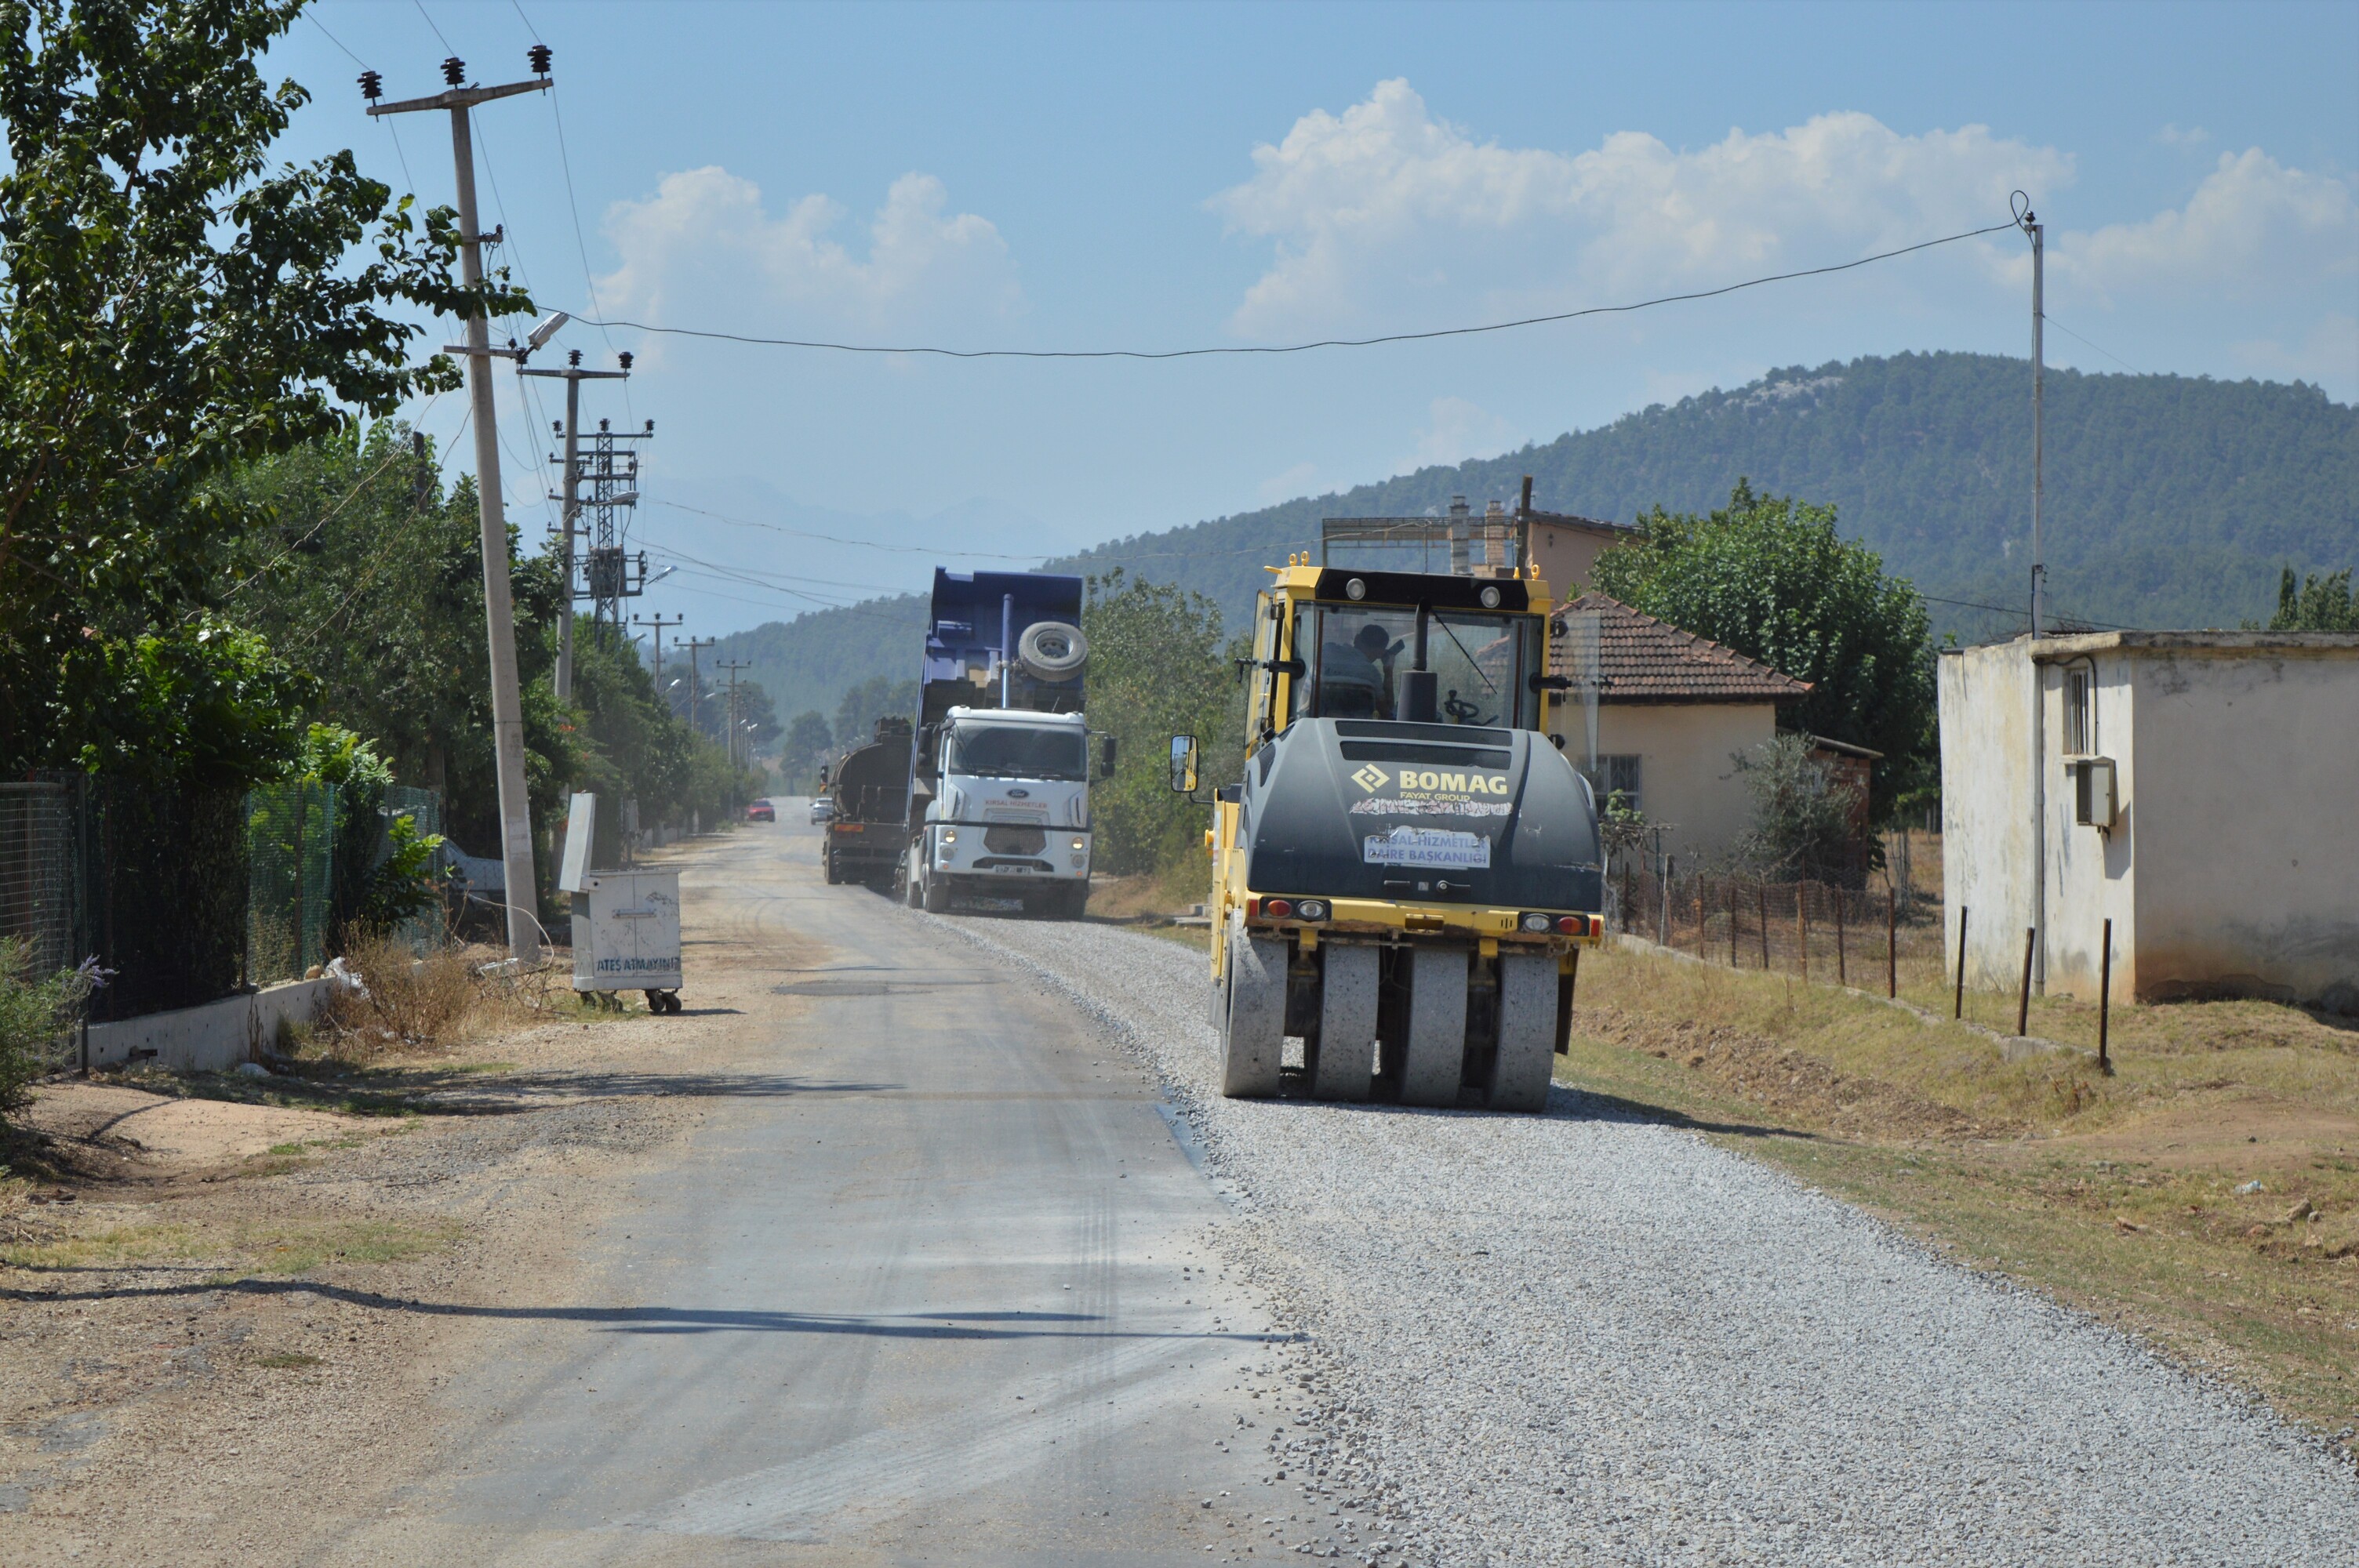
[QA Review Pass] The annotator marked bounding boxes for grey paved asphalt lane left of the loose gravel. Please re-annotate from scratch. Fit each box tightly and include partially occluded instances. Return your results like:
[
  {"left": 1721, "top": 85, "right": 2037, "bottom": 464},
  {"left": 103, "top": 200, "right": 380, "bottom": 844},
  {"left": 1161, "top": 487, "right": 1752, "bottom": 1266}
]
[{"left": 342, "top": 809, "right": 1276, "bottom": 1563}]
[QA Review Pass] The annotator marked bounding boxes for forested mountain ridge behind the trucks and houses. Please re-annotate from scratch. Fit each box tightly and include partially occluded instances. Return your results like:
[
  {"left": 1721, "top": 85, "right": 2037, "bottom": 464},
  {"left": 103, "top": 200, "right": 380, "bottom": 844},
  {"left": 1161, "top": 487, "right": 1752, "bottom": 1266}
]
[{"left": 714, "top": 354, "right": 2359, "bottom": 717}]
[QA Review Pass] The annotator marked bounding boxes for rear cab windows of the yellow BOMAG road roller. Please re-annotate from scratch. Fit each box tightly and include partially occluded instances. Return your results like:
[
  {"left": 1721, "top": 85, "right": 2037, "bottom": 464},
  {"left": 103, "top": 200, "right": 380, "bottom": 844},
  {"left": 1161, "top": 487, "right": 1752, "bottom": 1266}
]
[{"left": 1292, "top": 604, "right": 1540, "bottom": 728}]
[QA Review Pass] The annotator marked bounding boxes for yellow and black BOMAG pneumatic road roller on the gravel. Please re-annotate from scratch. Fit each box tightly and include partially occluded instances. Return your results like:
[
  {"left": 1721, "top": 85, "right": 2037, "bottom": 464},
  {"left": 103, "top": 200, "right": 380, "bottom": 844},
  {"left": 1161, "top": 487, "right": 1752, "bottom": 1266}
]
[{"left": 1172, "top": 537, "right": 1604, "bottom": 1111}]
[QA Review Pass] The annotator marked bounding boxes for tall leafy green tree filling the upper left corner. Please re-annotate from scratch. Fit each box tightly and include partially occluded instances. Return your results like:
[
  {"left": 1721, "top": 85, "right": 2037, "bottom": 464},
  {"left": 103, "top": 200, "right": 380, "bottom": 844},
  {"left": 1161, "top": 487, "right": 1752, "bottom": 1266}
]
[{"left": 0, "top": 0, "right": 531, "bottom": 780}]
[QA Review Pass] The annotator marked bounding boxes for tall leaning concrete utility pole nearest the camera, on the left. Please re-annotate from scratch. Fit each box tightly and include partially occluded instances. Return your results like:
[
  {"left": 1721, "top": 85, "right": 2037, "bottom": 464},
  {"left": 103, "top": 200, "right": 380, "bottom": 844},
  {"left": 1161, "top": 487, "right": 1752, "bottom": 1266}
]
[{"left": 361, "top": 45, "right": 554, "bottom": 969}]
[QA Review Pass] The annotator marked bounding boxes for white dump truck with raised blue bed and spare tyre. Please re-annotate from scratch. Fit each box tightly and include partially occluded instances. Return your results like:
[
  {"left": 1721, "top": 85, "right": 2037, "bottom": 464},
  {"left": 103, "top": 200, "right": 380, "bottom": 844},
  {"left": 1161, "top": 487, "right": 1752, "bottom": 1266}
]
[{"left": 901, "top": 568, "right": 1114, "bottom": 920}]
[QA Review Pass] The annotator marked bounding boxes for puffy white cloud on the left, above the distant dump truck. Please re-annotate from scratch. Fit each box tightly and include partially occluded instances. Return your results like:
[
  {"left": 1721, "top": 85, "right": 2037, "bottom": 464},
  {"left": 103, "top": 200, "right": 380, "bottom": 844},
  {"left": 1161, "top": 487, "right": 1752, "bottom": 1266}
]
[{"left": 599, "top": 165, "right": 1021, "bottom": 330}]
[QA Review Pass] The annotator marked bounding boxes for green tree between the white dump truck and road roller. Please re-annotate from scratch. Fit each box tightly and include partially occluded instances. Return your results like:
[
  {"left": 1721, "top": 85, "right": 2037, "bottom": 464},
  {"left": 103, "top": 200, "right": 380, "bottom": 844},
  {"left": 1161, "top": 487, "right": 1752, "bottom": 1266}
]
[{"left": 1081, "top": 568, "right": 1245, "bottom": 875}]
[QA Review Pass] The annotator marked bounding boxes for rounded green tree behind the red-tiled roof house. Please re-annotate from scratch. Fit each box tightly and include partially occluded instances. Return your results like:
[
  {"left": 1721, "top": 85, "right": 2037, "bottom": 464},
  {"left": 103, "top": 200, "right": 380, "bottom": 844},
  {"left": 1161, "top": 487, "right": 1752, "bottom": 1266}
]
[{"left": 1594, "top": 479, "right": 1939, "bottom": 821}]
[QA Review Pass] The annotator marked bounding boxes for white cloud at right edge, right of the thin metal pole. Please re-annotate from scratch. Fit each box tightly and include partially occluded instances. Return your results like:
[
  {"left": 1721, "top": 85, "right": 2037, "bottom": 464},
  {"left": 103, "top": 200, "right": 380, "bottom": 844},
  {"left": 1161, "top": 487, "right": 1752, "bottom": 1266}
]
[{"left": 2047, "top": 148, "right": 2359, "bottom": 304}]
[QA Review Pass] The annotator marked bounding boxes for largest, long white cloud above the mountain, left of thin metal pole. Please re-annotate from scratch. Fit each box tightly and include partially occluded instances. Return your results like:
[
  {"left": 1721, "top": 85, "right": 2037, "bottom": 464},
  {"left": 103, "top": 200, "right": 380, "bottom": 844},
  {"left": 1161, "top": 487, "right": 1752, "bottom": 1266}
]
[{"left": 1210, "top": 80, "right": 2074, "bottom": 335}]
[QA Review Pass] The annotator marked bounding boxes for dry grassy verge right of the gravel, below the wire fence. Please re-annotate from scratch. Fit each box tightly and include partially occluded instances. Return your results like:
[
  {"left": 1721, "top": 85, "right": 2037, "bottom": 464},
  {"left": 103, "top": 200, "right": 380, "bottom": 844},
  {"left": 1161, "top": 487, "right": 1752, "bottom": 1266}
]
[{"left": 1559, "top": 933, "right": 2359, "bottom": 1453}]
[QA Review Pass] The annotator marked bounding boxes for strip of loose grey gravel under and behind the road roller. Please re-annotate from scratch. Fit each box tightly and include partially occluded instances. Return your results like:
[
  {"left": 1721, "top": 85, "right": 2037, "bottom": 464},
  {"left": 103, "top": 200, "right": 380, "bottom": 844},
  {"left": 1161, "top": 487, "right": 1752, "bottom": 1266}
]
[{"left": 929, "top": 915, "right": 2359, "bottom": 1568}]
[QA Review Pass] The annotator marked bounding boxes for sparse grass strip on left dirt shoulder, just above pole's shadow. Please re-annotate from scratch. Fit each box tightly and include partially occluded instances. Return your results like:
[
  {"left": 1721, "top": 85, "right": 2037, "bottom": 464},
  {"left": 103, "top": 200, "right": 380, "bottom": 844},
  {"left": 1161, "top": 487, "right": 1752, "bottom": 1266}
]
[{"left": 0, "top": 1214, "right": 463, "bottom": 1285}]
